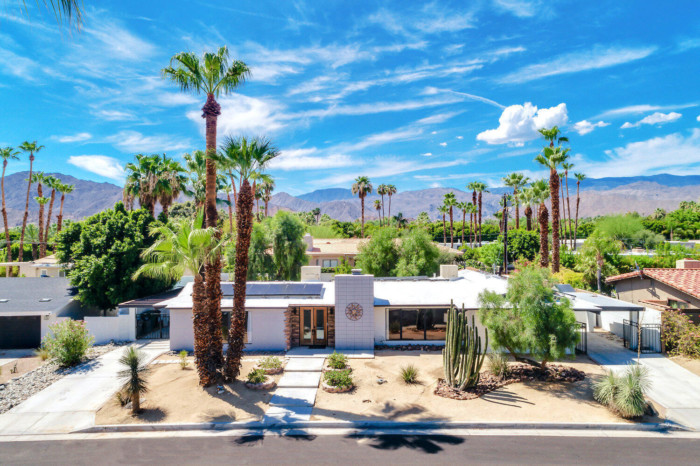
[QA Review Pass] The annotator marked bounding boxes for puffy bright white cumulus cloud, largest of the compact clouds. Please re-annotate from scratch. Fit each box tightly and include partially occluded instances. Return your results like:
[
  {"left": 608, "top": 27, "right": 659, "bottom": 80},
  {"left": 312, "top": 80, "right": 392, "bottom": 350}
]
[{"left": 476, "top": 102, "right": 569, "bottom": 145}]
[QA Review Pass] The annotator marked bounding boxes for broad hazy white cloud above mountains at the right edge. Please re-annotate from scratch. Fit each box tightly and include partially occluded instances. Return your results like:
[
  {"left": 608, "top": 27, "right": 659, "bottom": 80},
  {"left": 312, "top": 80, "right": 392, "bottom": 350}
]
[{"left": 574, "top": 128, "right": 700, "bottom": 178}]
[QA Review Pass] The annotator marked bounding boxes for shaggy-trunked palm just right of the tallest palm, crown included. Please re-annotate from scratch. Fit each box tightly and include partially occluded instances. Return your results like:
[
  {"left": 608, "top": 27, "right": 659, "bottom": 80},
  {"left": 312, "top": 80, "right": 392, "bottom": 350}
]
[{"left": 221, "top": 137, "right": 279, "bottom": 380}]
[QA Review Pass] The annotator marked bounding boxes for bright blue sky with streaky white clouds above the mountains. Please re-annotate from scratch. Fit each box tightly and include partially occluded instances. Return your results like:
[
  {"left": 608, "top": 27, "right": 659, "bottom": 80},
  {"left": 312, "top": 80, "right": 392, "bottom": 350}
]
[{"left": 0, "top": 0, "right": 700, "bottom": 194}]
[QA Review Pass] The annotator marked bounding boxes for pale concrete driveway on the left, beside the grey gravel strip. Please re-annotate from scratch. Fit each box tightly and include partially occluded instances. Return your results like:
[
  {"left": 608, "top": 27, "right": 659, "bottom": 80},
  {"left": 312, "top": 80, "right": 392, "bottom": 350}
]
[{"left": 0, "top": 340, "right": 169, "bottom": 435}]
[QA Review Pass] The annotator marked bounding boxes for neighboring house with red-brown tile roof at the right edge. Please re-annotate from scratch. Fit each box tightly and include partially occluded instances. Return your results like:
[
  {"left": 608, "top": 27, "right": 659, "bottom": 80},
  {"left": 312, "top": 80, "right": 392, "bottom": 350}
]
[{"left": 606, "top": 259, "right": 700, "bottom": 324}]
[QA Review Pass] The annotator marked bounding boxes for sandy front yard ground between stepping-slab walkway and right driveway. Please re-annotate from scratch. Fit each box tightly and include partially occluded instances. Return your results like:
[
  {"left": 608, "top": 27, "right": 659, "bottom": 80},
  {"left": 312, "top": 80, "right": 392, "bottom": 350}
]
[{"left": 311, "top": 351, "right": 652, "bottom": 422}]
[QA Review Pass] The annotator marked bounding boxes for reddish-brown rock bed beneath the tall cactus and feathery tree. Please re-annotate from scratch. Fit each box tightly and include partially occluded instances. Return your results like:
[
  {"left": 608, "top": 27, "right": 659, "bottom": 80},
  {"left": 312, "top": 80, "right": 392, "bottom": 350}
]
[{"left": 435, "top": 363, "right": 586, "bottom": 400}]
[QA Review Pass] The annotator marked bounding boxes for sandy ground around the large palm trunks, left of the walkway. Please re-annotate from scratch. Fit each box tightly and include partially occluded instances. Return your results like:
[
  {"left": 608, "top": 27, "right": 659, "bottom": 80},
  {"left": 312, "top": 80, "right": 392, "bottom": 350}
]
[{"left": 96, "top": 357, "right": 281, "bottom": 425}]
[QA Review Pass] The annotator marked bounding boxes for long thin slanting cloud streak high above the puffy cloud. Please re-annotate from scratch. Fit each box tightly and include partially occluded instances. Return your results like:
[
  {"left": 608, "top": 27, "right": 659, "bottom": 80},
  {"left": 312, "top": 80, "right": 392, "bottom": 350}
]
[{"left": 499, "top": 47, "right": 656, "bottom": 83}]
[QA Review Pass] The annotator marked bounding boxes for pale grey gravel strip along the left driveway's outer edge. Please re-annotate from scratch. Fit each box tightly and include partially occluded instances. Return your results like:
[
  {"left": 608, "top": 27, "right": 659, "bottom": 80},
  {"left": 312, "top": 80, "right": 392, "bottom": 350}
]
[{"left": 0, "top": 342, "right": 129, "bottom": 414}]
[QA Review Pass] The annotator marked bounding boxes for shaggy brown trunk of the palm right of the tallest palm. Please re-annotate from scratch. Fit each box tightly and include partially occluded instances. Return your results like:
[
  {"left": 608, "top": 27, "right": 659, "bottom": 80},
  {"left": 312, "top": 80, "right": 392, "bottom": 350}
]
[{"left": 224, "top": 180, "right": 253, "bottom": 380}]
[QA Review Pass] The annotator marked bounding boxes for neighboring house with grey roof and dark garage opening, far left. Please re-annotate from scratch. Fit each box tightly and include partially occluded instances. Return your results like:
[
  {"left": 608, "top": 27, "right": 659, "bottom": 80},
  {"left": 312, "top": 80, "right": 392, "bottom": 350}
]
[{"left": 0, "top": 278, "right": 85, "bottom": 349}]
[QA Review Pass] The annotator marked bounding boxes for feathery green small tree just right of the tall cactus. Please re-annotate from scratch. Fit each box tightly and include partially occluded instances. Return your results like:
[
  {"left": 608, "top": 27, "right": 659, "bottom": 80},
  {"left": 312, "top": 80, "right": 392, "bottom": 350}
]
[{"left": 479, "top": 265, "right": 578, "bottom": 369}]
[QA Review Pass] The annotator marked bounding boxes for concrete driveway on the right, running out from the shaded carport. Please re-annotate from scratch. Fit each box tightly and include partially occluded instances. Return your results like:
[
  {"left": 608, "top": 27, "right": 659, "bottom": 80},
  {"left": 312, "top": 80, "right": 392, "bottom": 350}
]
[{"left": 588, "top": 333, "right": 700, "bottom": 430}]
